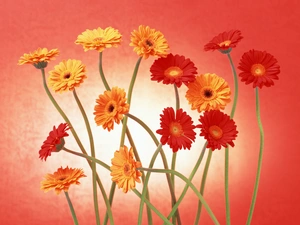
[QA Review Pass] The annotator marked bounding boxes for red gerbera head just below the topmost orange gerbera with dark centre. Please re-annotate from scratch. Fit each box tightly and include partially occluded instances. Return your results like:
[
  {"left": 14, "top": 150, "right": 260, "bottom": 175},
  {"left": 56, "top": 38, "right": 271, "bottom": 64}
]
[{"left": 150, "top": 54, "right": 197, "bottom": 87}]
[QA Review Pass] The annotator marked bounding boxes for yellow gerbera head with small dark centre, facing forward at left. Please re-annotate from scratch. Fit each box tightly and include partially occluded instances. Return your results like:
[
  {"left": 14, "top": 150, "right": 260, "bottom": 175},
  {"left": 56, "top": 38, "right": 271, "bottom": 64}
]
[{"left": 48, "top": 59, "right": 87, "bottom": 93}]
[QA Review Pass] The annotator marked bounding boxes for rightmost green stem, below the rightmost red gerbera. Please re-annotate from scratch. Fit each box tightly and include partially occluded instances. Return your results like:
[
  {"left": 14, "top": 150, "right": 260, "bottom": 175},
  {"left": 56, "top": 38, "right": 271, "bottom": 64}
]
[{"left": 246, "top": 87, "right": 264, "bottom": 225}]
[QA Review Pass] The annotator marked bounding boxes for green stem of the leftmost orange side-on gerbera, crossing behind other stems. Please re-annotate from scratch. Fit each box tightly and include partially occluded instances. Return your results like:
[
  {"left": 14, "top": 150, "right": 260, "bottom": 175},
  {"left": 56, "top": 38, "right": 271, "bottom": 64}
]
[{"left": 41, "top": 69, "right": 114, "bottom": 224}]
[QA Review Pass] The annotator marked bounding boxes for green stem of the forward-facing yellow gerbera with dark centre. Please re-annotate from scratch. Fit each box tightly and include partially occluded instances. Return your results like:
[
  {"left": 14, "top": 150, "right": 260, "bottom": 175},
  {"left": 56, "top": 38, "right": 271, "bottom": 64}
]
[{"left": 73, "top": 89, "right": 100, "bottom": 225}]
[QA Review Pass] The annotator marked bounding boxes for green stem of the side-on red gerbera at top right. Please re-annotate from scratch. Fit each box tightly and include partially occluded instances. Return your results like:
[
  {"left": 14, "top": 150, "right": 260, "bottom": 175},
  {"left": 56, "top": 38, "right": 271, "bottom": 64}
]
[{"left": 224, "top": 53, "right": 239, "bottom": 225}]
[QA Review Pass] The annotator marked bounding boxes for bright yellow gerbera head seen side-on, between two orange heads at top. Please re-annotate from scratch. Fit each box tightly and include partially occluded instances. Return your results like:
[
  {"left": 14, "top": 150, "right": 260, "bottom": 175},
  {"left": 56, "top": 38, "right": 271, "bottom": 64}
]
[{"left": 75, "top": 27, "right": 122, "bottom": 52}]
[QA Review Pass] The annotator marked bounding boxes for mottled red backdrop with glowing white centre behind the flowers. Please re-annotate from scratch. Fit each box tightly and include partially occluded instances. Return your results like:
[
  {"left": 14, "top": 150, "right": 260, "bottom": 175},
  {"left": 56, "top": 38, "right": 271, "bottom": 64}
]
[{"left": 0, "top": 0, "right": 300, "bottom": 225}]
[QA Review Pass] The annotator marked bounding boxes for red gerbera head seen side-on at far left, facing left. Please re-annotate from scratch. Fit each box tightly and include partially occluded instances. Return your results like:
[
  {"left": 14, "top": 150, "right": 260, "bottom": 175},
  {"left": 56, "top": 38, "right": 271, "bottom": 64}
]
[{"left": 39, "top": 123, "right": 70, "bottom": 161}]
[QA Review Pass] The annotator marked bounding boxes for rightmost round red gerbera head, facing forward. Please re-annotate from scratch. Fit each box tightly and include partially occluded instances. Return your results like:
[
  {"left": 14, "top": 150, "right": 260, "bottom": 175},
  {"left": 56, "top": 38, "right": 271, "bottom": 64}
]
[{"left": 238, "top": 50, "right": 280, "bottom": 88}]
